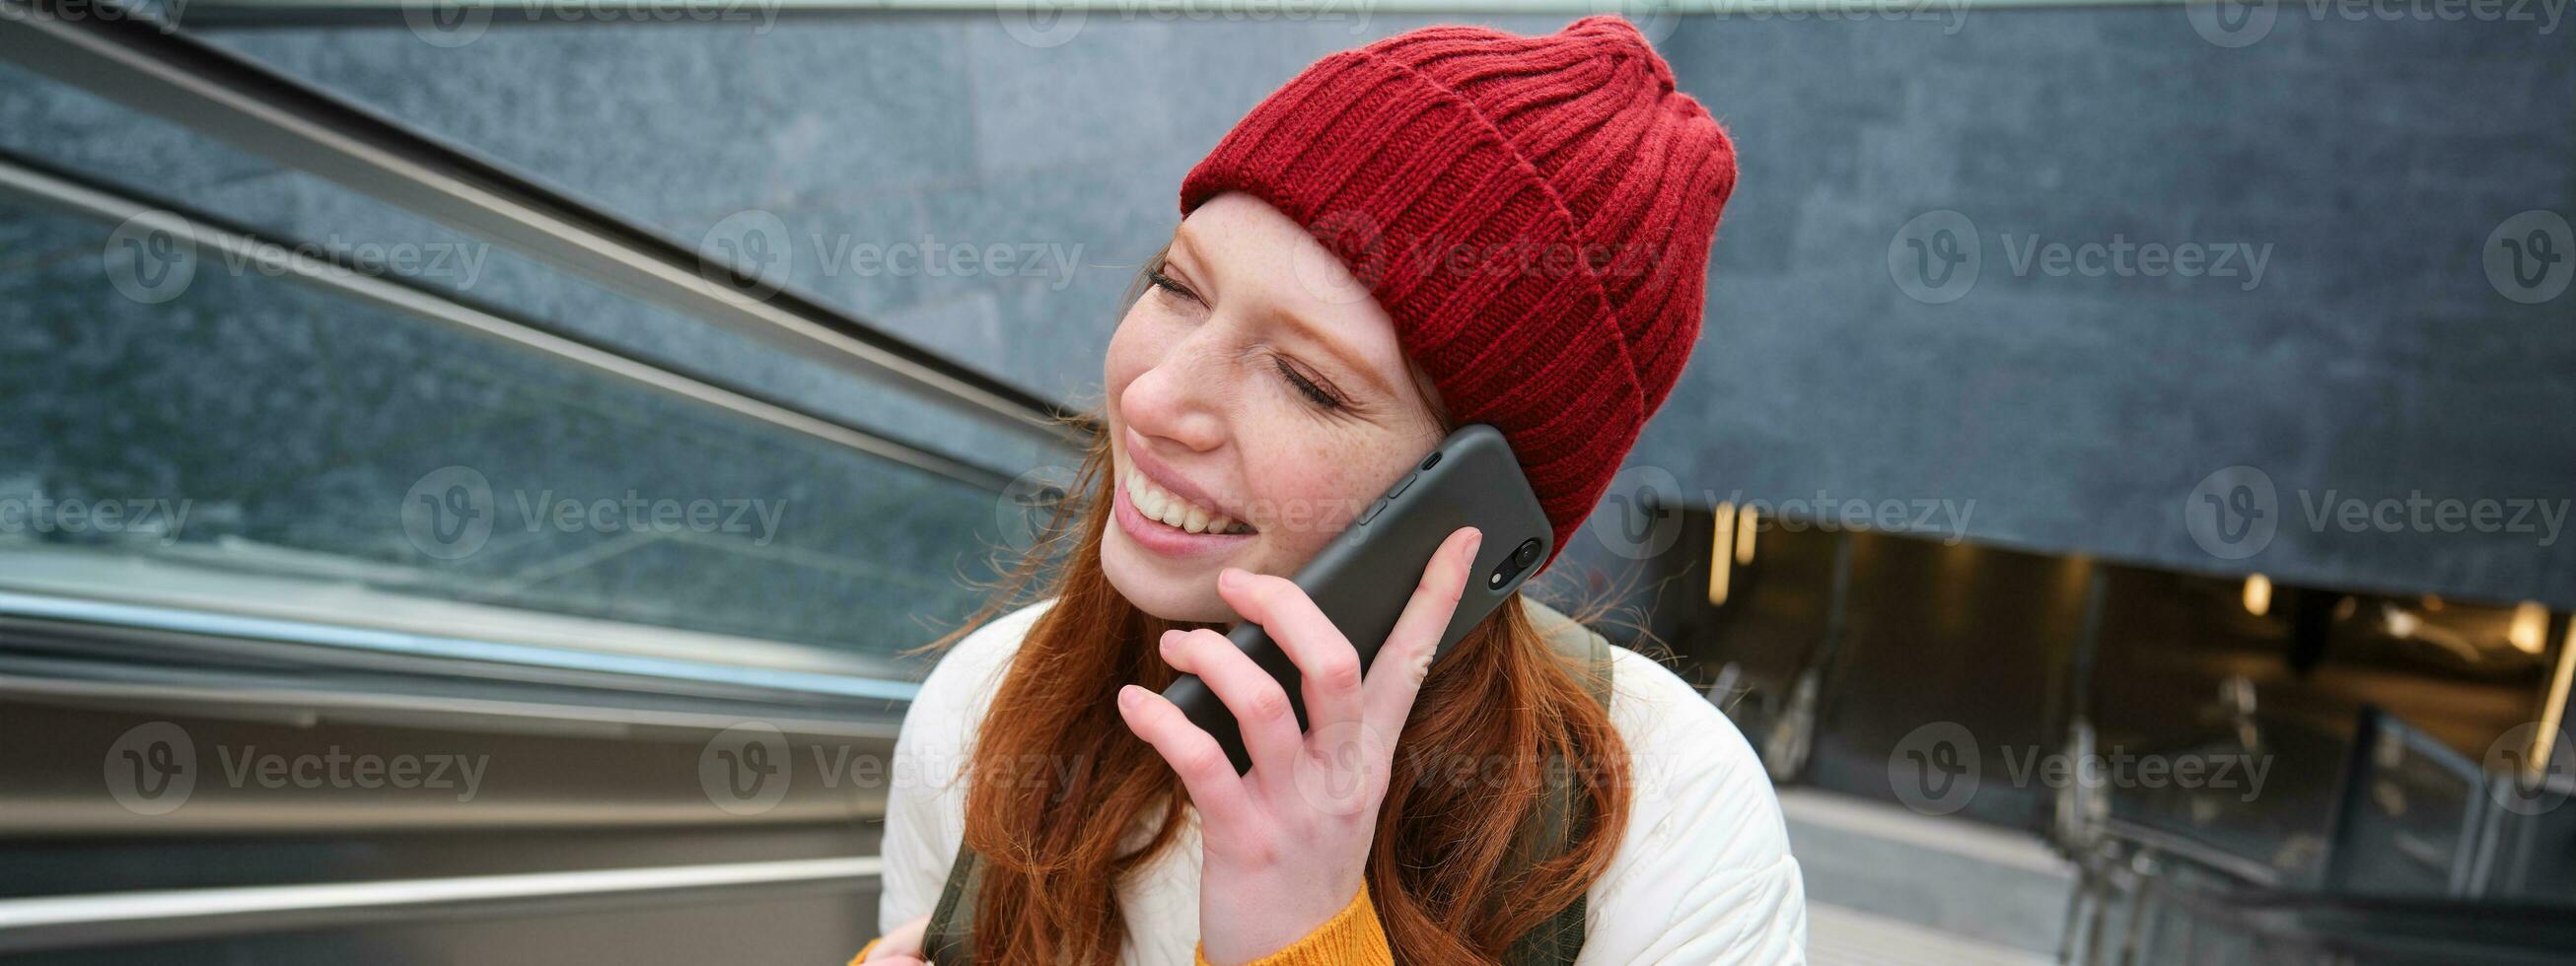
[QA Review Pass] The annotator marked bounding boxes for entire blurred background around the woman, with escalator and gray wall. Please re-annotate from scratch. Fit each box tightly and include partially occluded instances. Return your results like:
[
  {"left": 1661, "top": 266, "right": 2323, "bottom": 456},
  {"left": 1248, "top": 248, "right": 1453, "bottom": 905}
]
[{"left": 0, "top": 0, "right": 2576, "bottom": 963}]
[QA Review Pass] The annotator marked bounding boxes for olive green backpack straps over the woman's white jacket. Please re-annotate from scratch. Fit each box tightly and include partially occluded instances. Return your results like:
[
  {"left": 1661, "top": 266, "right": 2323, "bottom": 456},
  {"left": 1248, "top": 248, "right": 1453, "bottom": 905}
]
[{"left": 922, "top": 597, "right": 1610, "bottom": 966}]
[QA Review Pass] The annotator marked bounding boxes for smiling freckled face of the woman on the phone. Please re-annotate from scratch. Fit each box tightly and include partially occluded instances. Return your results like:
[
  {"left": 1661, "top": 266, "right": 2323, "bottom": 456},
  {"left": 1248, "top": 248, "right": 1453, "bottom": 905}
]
[{"left": 1100, "top": 193, "right": 1443, "bottom": 621}]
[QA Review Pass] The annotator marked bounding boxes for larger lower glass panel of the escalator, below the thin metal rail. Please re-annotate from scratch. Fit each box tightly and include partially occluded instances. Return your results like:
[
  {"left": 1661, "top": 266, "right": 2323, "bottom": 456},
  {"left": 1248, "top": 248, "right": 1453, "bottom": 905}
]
[{"left": 0, "top": 190, "right": 1015, "bottom": 656}]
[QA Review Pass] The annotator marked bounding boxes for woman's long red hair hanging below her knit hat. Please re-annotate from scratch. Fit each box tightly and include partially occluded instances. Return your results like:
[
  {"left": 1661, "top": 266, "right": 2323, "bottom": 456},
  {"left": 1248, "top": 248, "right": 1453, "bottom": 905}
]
[{"left": 927, "top": 261, "right": 1628, "bottom": 966}]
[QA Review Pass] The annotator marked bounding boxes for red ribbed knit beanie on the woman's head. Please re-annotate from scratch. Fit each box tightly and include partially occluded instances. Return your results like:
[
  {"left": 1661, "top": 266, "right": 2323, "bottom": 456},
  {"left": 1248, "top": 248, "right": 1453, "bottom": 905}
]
[{"left": 1180, "top": 16, "right": 1736, "bottom": 566}]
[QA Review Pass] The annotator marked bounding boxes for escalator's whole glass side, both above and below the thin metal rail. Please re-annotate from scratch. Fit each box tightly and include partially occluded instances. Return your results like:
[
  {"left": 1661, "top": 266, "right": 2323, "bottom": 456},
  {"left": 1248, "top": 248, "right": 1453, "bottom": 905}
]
[{"left": 0, "top": 43, "right": 1069, "bottom": 669}]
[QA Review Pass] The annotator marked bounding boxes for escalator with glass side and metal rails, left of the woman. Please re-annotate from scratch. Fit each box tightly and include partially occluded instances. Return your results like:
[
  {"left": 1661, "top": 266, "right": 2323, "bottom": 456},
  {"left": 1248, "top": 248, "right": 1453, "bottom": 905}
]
[{"left": 0, "top": 0, "right": 1087, "bottom": 963}]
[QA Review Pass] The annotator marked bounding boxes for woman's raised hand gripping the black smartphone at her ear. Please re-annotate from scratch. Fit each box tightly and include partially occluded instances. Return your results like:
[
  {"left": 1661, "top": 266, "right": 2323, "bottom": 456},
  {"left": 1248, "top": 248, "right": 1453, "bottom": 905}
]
[{"left": 1118, "top": 528, "right": 1484, "bottom": 963}]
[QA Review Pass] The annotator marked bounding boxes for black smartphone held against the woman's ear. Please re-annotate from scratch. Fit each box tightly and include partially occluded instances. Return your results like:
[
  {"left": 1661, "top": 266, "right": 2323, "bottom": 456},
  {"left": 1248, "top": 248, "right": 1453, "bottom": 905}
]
[{"left": 1162, "top": 423, "right": 1556, "bottom": 776}]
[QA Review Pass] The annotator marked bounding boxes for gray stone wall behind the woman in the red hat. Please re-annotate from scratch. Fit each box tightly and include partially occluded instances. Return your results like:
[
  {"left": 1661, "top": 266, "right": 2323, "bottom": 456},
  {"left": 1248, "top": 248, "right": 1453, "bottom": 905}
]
[{"left": 0, "top": 5, "right": 2576, "bottom": 652}]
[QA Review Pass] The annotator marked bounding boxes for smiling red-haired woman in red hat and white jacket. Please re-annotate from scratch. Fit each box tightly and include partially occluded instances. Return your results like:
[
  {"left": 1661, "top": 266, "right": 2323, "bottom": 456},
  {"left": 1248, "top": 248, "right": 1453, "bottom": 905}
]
[{"left": 860, "top": 16, "right": 1806, "bottom": 966}]
